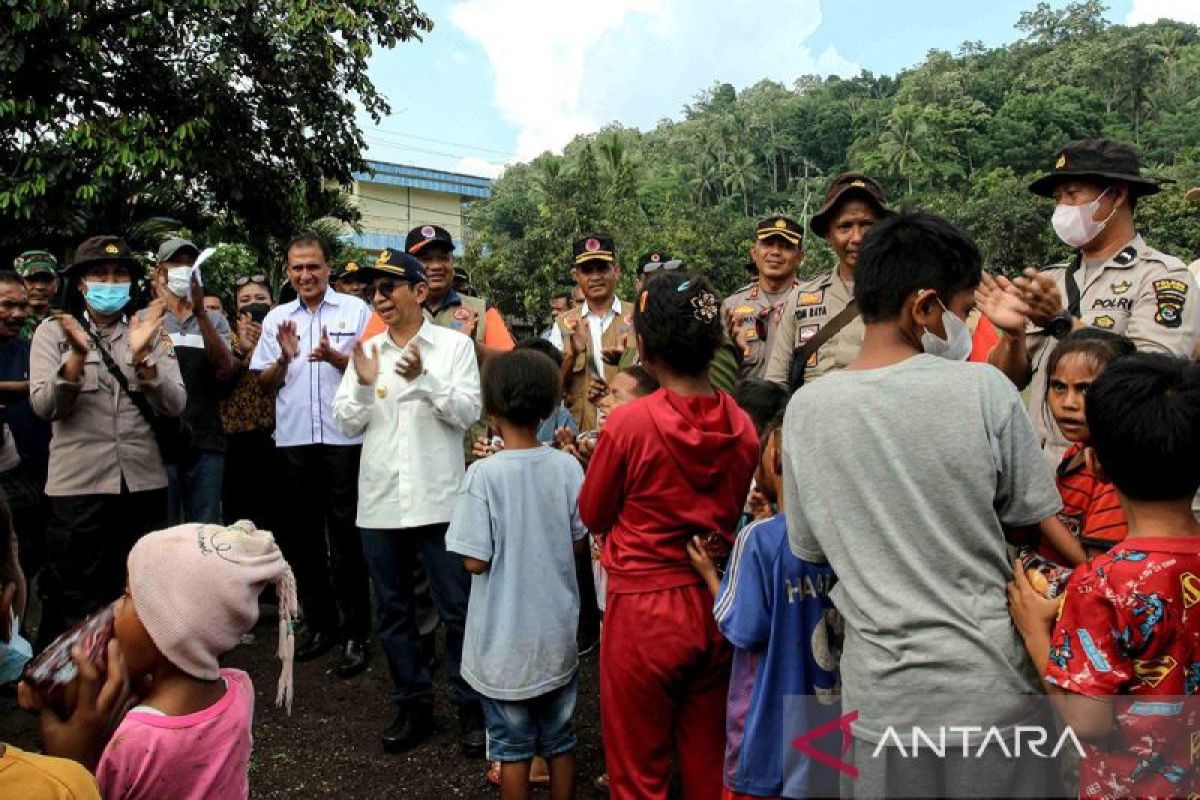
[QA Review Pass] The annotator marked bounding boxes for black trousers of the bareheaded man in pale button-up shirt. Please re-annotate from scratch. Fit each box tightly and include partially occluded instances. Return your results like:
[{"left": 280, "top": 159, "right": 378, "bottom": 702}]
[{"left": 275, "top": 445, "right": 371, "bottom": 639}]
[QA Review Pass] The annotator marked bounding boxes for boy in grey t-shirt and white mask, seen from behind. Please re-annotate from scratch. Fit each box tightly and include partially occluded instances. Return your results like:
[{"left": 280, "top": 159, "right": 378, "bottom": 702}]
[{"left": 784, "top": 213, "right": 1061, "bottom": 796}]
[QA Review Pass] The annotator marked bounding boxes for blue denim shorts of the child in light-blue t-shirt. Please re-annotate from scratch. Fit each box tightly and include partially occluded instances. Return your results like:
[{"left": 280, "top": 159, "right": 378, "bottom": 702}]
[{"left": 480, "top": 672, "right": 580, "bottom": 762}]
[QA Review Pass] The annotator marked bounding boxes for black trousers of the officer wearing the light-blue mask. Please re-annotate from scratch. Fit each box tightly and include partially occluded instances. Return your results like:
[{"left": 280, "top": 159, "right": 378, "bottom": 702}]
[{"left": 36, "top": 486, "right": 167, "bottom": 650}]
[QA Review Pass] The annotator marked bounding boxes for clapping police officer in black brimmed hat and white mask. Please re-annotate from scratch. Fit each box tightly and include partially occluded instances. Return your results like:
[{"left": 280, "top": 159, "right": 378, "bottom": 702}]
[{"left": 979, "top": 139, "right": 1200, "bottom": 464}]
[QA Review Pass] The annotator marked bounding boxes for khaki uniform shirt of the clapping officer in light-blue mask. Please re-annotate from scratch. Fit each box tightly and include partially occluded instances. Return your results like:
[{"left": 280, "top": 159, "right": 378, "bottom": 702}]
[{"left": 29, "top": 311, "right": 187, "bottom": 497}]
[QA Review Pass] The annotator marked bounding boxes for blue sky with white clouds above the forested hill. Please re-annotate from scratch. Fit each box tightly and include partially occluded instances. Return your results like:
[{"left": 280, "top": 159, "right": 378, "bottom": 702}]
[{"left": 359, "top": 0, "right": 1200, "bottom": 178}]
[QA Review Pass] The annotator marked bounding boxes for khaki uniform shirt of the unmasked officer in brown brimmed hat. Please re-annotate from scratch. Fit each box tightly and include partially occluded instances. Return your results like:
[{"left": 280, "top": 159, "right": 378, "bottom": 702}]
[{"left": 767, "top": 267, "right": 865, "bottom": 389}]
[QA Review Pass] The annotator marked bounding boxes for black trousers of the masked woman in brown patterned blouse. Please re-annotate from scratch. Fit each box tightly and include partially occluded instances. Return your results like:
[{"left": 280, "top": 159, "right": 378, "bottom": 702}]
[{"left": 221, "top": 431, "right": 288, "bottom": 533}]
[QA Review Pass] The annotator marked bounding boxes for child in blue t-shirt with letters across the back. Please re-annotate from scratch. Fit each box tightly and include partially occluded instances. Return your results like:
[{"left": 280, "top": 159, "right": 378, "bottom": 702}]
[{"left": 688, "top": 414, "right": 842, "bottom": 799}]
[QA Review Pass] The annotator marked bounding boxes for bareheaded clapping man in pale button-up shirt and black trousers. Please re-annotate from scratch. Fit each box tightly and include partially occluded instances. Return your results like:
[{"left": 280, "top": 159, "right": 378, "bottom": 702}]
[{"left": 250, "top": 234, "right": 371, "bottom": 678}]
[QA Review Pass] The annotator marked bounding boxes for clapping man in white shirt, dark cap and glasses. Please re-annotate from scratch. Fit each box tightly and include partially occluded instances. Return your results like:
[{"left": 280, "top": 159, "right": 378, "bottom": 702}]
[{"left": 334, "top": 249, "right": 485, "bottom": 756}]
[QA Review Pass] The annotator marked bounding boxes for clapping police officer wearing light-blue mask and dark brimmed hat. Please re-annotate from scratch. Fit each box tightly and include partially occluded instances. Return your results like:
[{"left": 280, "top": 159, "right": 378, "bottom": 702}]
[{"left": 29, "top": 236, "right": 187, "bottom": 645}]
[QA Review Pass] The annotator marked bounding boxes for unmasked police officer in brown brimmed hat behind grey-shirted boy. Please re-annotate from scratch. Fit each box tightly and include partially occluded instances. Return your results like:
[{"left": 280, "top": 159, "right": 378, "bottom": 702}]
[{"left": 767, "top": 173, "right": 892, "bottom": 387}]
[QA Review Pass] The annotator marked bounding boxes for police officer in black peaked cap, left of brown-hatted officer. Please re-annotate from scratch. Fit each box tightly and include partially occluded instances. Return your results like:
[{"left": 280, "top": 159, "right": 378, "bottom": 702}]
[{"left": 721, "top": 217, "right": 804, "bottom": 378}]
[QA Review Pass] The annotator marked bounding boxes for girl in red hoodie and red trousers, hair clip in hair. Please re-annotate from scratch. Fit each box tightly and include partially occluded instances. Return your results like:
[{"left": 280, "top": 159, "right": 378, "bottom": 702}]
[{"left": 580, "top": 272, "right": 758, "bottom": 800}]
